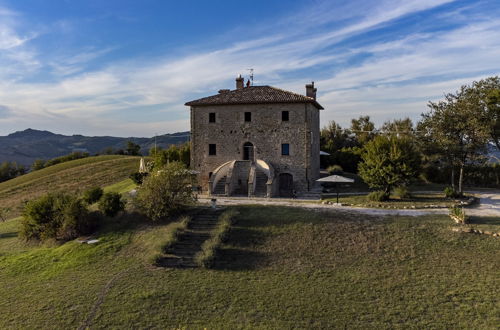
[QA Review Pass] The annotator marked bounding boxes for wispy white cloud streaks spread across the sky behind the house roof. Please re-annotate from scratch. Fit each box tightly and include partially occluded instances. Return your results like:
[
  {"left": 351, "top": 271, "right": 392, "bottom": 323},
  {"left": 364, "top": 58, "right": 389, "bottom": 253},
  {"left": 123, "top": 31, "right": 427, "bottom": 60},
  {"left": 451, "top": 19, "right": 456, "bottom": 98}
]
[{"left": 0, "top": 0, "right": 500, "bottom": 135}]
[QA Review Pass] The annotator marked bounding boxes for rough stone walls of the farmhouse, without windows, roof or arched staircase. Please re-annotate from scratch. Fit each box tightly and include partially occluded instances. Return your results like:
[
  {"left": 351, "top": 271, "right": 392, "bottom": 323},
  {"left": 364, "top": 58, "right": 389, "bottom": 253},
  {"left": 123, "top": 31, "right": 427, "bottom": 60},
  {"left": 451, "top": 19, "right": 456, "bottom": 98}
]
[{"left": 191, "top": 103, "right": 319, "bottom": 195}]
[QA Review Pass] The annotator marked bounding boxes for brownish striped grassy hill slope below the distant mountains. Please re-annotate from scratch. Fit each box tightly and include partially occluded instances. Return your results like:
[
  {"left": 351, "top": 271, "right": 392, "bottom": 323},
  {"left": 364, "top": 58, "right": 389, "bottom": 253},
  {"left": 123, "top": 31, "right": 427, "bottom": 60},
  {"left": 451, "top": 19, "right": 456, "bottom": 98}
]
[{"left": 0, "top": 155, "right": 140, "bottom": 215}]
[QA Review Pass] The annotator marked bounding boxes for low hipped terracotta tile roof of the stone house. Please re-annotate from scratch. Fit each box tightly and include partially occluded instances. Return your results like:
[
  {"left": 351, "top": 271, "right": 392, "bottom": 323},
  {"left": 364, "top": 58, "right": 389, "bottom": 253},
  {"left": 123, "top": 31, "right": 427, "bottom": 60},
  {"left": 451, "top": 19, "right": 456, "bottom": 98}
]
[{"left": 185, "top": 86, "right": 323, "bottom": 109}]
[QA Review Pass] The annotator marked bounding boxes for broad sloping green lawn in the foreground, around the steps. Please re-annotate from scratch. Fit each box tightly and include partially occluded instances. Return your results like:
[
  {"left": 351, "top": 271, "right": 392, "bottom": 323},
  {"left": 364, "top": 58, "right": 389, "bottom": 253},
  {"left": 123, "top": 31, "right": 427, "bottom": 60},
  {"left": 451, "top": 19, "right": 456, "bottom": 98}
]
[{"left": 0, "top": 206, "right": 500, "bottom": 329}]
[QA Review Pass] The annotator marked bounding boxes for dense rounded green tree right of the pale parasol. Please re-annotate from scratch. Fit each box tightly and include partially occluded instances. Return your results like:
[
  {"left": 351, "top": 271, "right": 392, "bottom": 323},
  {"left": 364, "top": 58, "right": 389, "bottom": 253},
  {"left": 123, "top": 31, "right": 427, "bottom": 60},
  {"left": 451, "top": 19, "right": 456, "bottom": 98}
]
[{"left": 359, "top": 135, "right": 420, "bottom": 197}]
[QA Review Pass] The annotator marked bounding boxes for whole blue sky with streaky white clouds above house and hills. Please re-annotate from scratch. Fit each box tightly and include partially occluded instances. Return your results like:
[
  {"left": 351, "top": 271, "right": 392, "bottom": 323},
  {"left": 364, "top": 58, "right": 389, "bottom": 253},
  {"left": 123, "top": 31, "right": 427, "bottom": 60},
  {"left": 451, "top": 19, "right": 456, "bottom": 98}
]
[{"left": 0, "top": 0, "right": 500, "bottom": 136}]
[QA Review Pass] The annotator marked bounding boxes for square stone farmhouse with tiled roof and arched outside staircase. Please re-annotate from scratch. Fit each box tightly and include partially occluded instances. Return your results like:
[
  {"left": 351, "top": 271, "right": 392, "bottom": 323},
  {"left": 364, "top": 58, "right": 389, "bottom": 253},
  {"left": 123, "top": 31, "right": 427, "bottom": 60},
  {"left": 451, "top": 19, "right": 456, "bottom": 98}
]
[{"left": 186, "top": 76, "right": 323, "bottom": 197}]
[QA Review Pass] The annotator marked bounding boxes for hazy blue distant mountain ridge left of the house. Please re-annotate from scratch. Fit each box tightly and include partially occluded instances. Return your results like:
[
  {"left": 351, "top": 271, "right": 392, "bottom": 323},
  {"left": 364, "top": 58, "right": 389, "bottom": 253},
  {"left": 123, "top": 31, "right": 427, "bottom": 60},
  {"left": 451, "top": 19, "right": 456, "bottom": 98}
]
[{"left": 0, "top": 128, "right": 189, "bottom": 166}]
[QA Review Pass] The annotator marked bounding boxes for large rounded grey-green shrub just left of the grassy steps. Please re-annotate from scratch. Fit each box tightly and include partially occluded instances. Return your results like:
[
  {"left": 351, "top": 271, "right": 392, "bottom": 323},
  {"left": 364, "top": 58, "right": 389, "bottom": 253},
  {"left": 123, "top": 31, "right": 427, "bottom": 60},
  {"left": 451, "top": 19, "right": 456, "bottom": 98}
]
[{"left": 135, "top": 162, "right": 196, "bottom": 221}]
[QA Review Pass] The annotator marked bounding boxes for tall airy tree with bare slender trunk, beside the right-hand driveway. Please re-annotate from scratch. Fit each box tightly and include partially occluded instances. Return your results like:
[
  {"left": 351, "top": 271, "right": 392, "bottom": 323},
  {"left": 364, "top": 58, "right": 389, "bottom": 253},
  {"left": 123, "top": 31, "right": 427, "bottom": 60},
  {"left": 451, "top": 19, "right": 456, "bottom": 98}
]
[{"left": 418, "top": 86, "right": 491, "bottom": 194}]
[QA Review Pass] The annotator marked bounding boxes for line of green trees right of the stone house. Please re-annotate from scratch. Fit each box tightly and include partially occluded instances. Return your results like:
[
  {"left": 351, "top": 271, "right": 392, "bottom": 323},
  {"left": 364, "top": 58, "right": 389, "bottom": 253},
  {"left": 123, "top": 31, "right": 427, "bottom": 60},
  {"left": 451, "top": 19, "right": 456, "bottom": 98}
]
[{"left": 320, "top": 77, "right": 500, "bottom": 195}]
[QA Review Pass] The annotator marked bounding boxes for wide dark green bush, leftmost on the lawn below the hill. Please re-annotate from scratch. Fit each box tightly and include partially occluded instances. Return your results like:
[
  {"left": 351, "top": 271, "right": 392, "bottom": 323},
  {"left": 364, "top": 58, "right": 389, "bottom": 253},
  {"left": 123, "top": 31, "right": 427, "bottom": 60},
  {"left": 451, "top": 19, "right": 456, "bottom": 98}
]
[{"left": 21, "top": 193, "right": 98, "bottom": 240}]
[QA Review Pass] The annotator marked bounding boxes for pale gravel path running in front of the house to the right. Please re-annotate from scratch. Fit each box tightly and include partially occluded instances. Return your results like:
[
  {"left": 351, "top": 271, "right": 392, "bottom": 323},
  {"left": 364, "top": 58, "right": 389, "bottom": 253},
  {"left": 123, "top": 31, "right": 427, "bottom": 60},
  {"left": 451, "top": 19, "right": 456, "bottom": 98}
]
[{"left": 199, "top": 191, "right": 500, "bottom": 217}]
